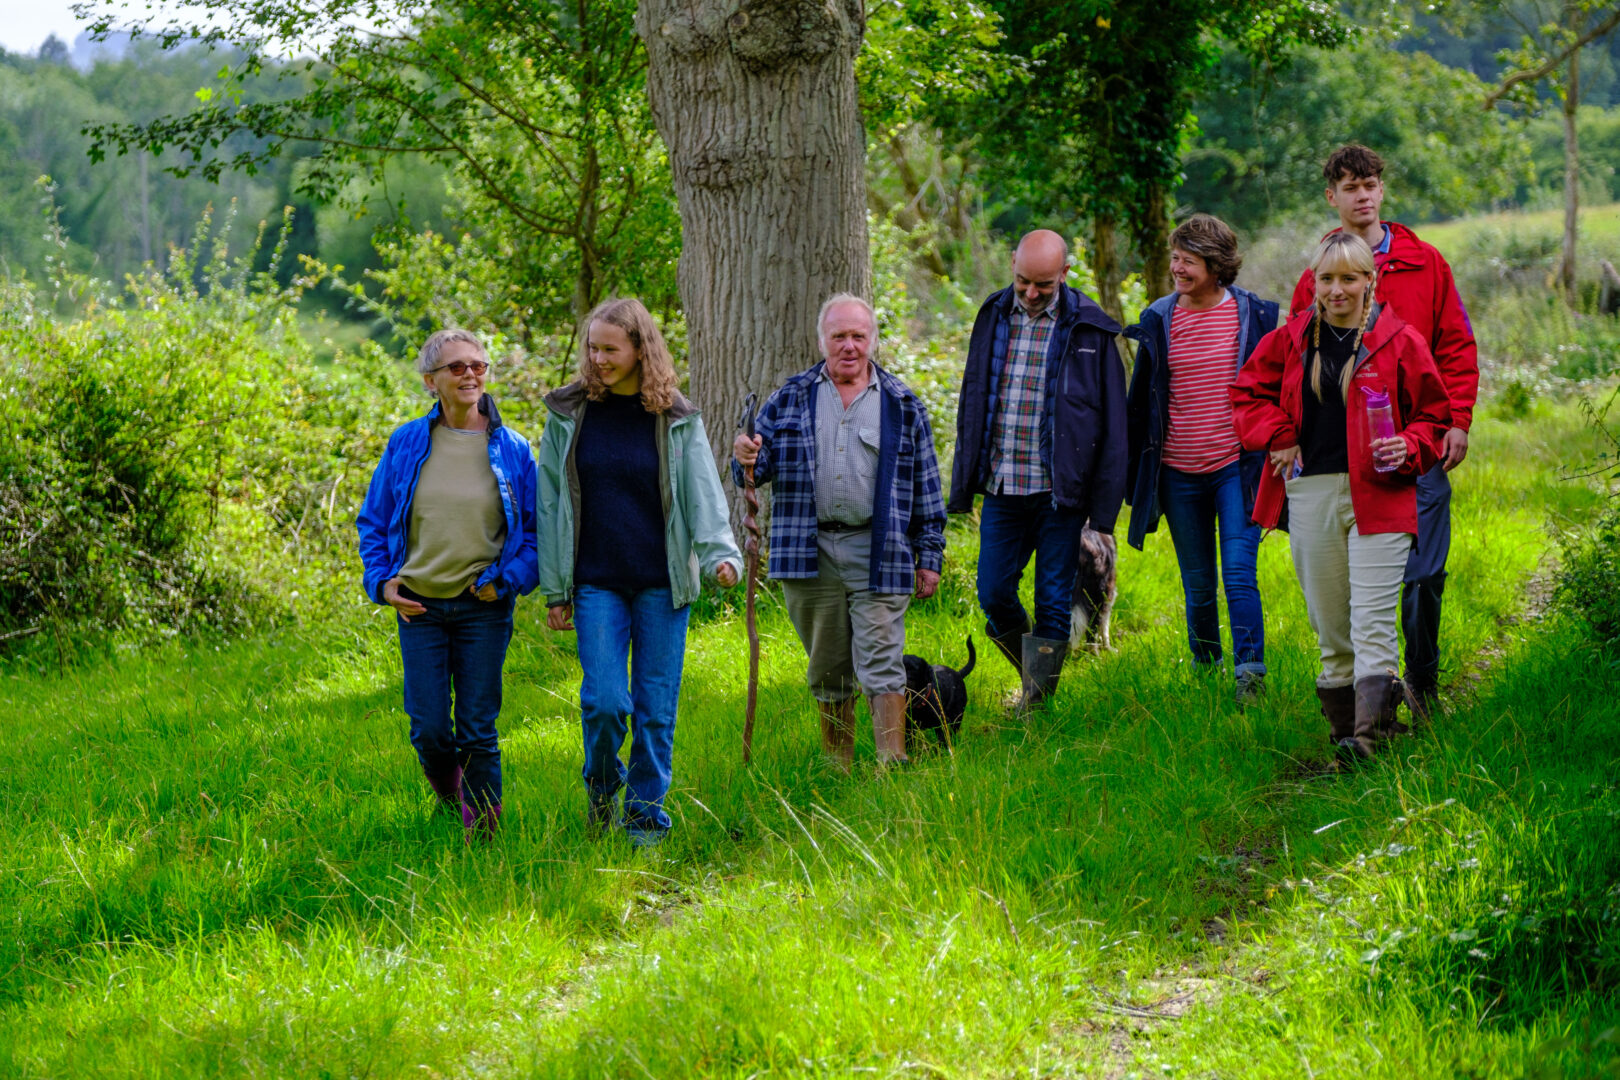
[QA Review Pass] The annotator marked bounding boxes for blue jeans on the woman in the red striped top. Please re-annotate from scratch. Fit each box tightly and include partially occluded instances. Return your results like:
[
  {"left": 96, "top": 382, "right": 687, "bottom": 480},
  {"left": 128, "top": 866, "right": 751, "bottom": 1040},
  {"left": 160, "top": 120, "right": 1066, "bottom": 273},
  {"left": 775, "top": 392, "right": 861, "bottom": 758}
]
[{"left": 1158, "top": 461, "right": 1265, "bottom": 675}]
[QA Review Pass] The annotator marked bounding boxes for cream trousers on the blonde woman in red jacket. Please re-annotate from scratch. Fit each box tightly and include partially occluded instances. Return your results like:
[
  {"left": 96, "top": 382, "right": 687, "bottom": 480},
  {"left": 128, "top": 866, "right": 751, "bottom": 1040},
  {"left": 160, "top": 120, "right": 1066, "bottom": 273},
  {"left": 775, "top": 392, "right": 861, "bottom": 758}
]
[{"left": 1288, "top": 473, "right": 1413, "bottom": 690}]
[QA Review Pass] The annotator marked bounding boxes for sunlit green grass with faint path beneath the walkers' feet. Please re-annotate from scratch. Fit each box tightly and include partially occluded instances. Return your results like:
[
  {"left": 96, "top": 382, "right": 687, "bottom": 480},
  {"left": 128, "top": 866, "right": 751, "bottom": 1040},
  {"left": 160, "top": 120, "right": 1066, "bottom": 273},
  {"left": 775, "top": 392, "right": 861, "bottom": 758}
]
[{"left": 0, "top": 401, "right": 1620, "bottom": 1080}]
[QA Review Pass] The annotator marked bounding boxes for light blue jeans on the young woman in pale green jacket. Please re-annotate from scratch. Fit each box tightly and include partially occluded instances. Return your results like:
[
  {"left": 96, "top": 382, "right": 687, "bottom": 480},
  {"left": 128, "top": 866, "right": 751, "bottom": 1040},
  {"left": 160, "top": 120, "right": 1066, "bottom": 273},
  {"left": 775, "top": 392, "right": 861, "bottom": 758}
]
[{"left": 573, "top": 585, "right": 692, "bottom": 839}]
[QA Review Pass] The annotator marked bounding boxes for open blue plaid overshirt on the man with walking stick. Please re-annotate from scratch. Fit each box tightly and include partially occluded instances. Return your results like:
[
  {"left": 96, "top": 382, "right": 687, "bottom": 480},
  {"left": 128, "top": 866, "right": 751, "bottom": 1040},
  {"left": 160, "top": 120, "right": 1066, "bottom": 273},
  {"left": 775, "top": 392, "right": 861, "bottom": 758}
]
[{"left": 731, "top": 364, "right": 944, "bottom": 593}]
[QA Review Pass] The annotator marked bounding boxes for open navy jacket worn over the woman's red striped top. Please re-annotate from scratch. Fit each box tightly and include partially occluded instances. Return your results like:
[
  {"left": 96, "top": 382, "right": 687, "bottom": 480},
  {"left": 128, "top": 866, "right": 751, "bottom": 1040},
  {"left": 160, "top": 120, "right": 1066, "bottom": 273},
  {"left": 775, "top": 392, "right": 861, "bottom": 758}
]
[{"left": 1124, "top": 285, "right": 1277, "bottom": 551}]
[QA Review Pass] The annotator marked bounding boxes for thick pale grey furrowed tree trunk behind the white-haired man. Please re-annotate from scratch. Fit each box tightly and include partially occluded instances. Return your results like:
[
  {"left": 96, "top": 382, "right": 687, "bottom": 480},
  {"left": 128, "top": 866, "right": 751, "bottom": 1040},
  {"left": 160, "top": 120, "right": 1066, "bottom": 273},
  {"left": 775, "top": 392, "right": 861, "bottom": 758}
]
[{"left": 635, "top": 0, "right": 872, "bottom": 476}]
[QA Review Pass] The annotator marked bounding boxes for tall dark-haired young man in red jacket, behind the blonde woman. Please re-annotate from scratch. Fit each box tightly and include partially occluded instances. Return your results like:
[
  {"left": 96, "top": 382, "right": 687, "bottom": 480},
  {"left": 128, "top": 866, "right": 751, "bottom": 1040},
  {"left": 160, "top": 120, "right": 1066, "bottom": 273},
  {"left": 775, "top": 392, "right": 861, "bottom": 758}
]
[{"left": 1290, "top": 144, "right": 1479, "bottom": 718}]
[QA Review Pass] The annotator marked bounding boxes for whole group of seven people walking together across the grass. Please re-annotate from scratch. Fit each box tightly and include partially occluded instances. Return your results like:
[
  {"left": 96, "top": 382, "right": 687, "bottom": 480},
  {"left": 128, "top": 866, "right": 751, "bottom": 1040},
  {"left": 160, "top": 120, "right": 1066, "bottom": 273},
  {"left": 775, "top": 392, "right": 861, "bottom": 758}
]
[{"left": 358, "top": 146, "right": 1479, "bottom": 845}]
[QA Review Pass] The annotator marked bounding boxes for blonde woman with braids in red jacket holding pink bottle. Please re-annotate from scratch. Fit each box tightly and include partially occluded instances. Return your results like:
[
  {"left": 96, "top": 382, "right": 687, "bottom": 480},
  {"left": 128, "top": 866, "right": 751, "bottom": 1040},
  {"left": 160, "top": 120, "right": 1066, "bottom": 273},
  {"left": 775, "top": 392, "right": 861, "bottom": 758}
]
[{"left": 1231, "top": 232, "right": 1452, "bottom": 761}]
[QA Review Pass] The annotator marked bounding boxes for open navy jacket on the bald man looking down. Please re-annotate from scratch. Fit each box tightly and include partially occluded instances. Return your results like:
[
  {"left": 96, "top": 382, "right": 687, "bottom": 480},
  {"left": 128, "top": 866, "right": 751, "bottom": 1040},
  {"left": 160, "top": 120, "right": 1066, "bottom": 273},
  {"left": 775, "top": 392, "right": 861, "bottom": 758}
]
[{"left": 946, "top": 285, "right": 1126, "bottom": 533}]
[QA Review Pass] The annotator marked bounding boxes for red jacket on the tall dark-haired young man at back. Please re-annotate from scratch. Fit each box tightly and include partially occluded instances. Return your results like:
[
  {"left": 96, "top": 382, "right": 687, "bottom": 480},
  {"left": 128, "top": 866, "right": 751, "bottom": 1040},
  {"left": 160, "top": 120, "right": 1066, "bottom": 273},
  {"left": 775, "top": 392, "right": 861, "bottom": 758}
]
[{"left": 1288, "top": 222, "right": 1479, "bottom": 431}]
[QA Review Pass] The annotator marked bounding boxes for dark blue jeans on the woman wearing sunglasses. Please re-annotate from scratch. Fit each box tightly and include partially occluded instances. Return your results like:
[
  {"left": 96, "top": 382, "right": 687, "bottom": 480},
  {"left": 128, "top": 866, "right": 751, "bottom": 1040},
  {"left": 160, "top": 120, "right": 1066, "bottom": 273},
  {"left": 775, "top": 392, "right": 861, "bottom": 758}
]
[{"left": 399, "top": 589, "right": 515, "bottom": 808}]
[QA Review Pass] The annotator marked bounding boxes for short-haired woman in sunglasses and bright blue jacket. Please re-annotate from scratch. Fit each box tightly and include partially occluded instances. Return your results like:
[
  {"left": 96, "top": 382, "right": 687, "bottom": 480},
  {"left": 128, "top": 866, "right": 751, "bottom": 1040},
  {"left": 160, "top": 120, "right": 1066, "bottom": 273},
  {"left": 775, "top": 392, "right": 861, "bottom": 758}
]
[{"left": 356, "top": 330, "right": 539, "bottom": 839}]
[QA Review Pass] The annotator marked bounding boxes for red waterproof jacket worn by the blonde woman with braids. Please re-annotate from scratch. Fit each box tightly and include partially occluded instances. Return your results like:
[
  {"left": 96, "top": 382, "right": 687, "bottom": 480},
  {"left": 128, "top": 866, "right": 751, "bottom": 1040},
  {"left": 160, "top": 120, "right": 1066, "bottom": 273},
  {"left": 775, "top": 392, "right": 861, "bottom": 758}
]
[{"left": 1231, "top": 308, "right": 1452, "bottom": 534}]
